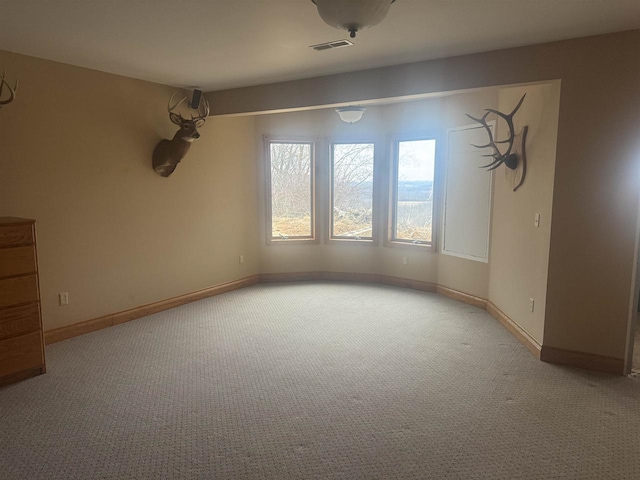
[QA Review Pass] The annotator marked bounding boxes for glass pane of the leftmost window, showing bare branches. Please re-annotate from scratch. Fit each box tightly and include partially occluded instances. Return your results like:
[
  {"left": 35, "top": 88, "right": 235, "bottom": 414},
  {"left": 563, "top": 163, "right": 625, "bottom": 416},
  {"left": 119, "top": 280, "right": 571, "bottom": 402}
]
[{"left": 270, "top": 143, "right": 313, "bottom": 238}]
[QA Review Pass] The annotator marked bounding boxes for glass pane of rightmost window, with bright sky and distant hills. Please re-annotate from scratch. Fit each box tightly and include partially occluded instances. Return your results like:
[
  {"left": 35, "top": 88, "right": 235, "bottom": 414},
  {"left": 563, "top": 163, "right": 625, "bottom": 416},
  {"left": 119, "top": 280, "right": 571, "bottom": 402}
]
[{"left": 393, "top": 140, "right": 436, "bottom": 243}]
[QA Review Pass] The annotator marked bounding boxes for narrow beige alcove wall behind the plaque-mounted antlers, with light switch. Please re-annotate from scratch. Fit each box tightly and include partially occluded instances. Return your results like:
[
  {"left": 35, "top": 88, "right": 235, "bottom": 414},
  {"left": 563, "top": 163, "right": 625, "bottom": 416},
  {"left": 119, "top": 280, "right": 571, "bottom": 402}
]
[{"left": 489, "top": 81, "right": 560, "bottom": 345}]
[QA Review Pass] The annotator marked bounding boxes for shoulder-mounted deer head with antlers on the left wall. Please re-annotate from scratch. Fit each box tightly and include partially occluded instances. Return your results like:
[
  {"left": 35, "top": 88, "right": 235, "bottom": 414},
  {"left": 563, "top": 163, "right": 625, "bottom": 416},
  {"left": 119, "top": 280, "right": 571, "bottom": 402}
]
[{"left": 152, "top": 93, "right": 209, "bottom": 177}]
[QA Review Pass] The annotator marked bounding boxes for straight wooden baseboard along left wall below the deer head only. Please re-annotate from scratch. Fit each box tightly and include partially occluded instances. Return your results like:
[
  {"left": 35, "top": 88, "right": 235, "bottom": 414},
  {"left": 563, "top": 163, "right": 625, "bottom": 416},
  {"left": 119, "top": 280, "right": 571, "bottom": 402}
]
[{"left": 44, "top": 275, "right": 259, "bottom": 345}]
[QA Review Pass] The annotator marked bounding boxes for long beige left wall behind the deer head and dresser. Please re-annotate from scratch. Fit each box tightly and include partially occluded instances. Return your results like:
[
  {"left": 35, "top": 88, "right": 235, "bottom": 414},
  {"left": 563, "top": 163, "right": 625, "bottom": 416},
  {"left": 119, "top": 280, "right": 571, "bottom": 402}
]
[{"left": 0, "top": 52, "right": 258, "bottom": 330}]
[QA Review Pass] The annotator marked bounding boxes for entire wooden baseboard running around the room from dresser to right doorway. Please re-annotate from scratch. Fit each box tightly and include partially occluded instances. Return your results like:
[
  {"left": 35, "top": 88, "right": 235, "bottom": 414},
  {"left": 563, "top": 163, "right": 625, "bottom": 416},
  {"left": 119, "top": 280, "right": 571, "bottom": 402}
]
[{"left": 38, "top": 272, "right": 624, "bottom": 375}]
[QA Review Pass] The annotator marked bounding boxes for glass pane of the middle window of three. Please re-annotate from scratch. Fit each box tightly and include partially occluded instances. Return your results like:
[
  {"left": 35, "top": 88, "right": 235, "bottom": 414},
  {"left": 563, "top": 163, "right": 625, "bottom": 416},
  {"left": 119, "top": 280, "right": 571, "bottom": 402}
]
[{"left": 331, "top": 143, "right": 373, "bottom": 239}]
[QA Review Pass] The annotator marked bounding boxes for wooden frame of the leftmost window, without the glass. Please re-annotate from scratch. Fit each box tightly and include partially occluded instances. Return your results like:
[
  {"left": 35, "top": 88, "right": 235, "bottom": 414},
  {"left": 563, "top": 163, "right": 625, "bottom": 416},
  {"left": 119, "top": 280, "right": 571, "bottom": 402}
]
[{"left": 263, "top": 135, "right": 318, "bottom": 245}]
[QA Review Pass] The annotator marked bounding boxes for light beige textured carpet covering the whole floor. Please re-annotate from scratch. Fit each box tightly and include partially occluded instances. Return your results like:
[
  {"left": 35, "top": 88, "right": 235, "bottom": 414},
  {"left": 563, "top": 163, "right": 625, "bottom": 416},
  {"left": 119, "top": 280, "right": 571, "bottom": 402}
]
[{"left": 0, "top": 282, "right": 640, "bottom": 480}]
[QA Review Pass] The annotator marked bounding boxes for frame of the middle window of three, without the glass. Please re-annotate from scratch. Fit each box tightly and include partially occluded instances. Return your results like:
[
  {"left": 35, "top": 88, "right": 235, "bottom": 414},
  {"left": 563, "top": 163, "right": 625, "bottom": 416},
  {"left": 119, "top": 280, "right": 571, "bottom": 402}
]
[{"left": 325, "top": 137, "right": 379, "bottom": 246}]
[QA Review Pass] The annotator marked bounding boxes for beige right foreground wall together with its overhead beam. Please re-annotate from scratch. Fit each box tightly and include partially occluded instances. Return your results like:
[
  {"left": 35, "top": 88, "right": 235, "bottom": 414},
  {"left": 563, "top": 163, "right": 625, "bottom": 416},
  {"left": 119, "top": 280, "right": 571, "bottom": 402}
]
[{"left": 208, "top": 30, "right": 640, "bottom": 359}]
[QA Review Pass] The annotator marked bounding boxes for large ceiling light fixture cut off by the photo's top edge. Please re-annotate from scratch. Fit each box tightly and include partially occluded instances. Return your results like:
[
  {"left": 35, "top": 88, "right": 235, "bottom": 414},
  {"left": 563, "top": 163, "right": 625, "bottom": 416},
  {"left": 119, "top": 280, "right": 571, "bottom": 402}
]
[{"left": 311, "top": 0, "right": 396, "bottom": 38}]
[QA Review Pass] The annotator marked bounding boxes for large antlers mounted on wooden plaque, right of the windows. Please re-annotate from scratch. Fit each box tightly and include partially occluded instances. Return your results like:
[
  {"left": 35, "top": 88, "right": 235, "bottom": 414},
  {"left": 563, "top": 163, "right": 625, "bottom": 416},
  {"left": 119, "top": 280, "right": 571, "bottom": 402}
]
[{"left": 467, "top": 93, "right": 529, "bottom": 192}]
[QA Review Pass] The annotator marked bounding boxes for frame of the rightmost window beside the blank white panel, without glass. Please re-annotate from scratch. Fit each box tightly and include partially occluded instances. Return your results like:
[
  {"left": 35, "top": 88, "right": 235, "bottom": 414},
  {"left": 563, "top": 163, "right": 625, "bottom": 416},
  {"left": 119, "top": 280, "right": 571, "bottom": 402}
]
[{"left": 384, "top": 132, "right": 441, "bottom": 252}]
